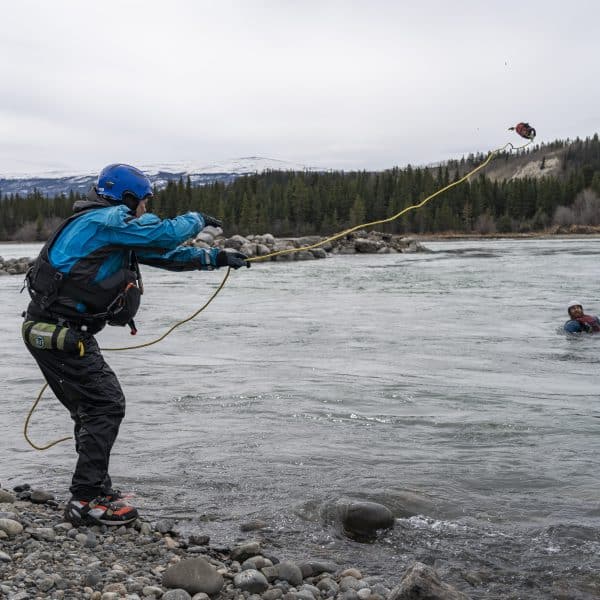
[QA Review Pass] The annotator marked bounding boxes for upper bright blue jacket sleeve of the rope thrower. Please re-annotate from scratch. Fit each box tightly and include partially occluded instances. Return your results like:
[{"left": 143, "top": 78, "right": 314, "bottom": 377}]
[{"left": 100, "top": 206, "right": 204, "bottom": 252}]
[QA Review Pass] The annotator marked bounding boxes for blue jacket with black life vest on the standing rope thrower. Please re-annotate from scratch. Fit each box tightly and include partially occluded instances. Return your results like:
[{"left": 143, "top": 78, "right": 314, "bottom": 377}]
[{"left": 27, "top": 190, "right": 218, "bottom": 333}]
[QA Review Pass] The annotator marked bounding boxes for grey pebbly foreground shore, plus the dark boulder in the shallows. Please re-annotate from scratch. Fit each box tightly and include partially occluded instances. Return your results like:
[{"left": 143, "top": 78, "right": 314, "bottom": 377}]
[{"left": 0, "top": 484, "right": 468, "bottom": 600}]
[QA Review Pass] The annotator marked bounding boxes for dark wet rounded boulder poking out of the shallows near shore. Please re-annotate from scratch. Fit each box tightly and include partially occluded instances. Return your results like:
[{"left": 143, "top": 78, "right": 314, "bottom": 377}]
[{"left": 335, "top": 499, "right": 394, "bottom": 541}]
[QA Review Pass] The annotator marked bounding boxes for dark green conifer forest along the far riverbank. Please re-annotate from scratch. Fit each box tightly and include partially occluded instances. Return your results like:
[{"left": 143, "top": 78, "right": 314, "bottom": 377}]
[{"left": 0, "top": 134, "right": 600, "bottom": 240}]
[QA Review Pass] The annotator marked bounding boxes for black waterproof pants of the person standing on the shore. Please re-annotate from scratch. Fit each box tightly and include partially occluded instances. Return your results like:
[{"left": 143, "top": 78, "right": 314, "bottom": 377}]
[{"left": 26, "top": 336, "right": 125, "bottom": 500}]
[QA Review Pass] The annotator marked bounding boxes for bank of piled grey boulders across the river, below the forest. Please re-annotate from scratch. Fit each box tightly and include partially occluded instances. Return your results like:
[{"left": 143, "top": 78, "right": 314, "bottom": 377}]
[{"left": 0, "top": 226, "right": 429, "bottom": 276}]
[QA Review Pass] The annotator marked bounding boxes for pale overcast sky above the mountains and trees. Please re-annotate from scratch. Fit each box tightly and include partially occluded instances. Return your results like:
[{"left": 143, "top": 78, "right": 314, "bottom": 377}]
[{"left": 0, "top": 0, "right": 600, "bottom": 177}]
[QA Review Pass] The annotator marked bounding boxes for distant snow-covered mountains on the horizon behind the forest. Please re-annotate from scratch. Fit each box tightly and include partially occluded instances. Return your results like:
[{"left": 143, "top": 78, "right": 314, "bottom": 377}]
[{"left": 0, "top": 156, "right": 324, "bottom": 196}]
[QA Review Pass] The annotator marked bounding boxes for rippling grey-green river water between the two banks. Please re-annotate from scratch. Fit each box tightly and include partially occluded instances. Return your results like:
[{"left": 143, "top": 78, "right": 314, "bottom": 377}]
[{"left": 0, "top": 239, "right": 600, "bottom": 598}]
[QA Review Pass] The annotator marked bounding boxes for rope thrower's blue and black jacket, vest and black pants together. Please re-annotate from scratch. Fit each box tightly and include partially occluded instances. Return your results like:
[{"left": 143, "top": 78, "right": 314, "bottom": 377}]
[{"left": 26, "top": 191, "right": 218, "bottom": 500}]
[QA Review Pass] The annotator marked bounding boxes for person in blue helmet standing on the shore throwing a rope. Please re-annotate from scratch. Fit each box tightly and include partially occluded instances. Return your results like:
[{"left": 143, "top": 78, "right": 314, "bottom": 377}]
[{"left": 22, "top": 164, "right": 250, "bottom": 525}]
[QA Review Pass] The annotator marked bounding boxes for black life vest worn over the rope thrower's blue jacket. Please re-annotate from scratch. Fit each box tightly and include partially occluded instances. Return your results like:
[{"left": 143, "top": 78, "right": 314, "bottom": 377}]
[{"left": 25, "top": 206, "right": 143, "bottom": 333}]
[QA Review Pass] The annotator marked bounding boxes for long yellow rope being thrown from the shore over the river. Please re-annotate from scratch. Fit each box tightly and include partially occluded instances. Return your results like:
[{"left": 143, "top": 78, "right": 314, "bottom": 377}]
[{"left": 23, "top": 140, "right": 533, "bottom": 450}]
